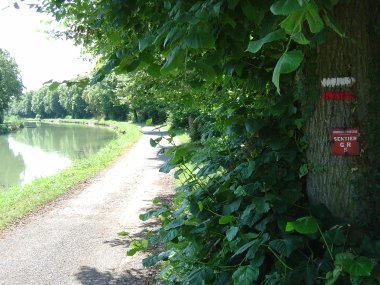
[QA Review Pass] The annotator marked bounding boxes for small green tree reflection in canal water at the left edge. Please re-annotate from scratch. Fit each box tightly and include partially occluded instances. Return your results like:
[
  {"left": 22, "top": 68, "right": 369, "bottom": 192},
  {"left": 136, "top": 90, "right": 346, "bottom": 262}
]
[{"left": 0, "top": 136, "right": 25, "bottom": 188}]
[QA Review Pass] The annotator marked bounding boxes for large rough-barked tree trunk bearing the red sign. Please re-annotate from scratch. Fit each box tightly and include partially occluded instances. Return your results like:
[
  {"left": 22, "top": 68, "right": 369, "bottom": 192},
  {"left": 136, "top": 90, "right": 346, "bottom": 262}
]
[{"left": 306, "top": 0, "right": 379, "bottom": 222}]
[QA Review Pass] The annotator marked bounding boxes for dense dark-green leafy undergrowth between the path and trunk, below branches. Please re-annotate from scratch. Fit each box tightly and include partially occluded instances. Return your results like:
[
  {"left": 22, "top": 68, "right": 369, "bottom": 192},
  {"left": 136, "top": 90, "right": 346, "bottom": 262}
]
[{"left": 129, "top": 86, "right": 380, "bottom": 285}]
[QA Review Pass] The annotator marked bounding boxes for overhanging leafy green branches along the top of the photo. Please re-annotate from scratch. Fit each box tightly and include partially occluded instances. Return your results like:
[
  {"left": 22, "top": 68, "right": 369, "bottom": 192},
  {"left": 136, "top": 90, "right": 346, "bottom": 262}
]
[{"left": 40, "top": 0, "right": 339, "bottom": 92}]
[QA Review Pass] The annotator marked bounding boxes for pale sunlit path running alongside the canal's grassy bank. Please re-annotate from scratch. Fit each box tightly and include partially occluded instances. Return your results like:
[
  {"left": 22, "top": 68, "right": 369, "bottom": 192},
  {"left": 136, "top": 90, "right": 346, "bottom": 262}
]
[{"left": 0, "top": 128, "right": 173, "bottom": 285}]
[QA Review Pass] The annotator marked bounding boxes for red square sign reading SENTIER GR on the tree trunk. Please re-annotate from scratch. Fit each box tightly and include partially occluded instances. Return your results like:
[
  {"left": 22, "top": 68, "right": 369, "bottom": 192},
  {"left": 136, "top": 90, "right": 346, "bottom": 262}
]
[{"left": 330, "top": 128, "right": 360, "bottom": 156}]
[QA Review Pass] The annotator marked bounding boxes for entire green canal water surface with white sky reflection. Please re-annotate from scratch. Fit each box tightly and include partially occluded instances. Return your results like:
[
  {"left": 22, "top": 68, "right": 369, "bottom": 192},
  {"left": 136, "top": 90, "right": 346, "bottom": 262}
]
[{"left": 0, "top": 123, "right": 116, "bottom": 186}]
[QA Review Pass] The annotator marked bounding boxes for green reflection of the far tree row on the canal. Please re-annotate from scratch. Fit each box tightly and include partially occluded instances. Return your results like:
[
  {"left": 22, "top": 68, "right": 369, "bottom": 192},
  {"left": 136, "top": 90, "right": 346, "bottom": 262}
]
[{"left": 12, "top": 124, "right": 115, "bottom": 159}]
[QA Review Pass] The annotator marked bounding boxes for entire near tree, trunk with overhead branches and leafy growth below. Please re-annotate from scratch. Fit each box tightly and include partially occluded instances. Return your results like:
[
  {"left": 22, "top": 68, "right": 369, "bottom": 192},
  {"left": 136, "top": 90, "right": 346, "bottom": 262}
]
[{"left": 33, "top": 0, "right": 380, "bottom": 285}]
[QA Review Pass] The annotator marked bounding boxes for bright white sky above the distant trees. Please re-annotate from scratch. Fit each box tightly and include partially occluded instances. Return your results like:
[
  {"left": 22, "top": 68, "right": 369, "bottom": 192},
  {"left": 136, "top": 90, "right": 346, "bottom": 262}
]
[{"left": 0, "top": 0, "right": 95, "bottom": 90}]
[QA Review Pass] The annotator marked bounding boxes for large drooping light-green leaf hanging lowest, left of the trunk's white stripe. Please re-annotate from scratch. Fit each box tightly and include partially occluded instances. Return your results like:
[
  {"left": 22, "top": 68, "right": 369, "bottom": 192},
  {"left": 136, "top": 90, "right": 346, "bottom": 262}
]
[{"left": 272, "top": 50, "right": 303, "bottom": 93}]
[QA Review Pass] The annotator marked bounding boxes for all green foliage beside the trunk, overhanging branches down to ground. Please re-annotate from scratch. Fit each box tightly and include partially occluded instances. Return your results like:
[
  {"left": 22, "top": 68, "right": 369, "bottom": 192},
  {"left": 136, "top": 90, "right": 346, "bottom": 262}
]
[{"left": 38, "top": 0, "right": 380, "bottom": 285}]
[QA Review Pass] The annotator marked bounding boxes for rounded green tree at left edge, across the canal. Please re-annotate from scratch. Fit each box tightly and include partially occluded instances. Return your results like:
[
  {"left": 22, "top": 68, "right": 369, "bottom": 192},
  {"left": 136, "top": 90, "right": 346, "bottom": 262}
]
[{"left": 0, "top": 49, "right": 23, "bottom": 124}]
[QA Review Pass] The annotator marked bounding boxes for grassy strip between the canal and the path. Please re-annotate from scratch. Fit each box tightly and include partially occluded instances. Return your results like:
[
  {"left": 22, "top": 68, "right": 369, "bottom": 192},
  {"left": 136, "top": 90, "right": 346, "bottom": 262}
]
[{"left": 0, "top": 120, "right": 142, "bottom": 229}]
